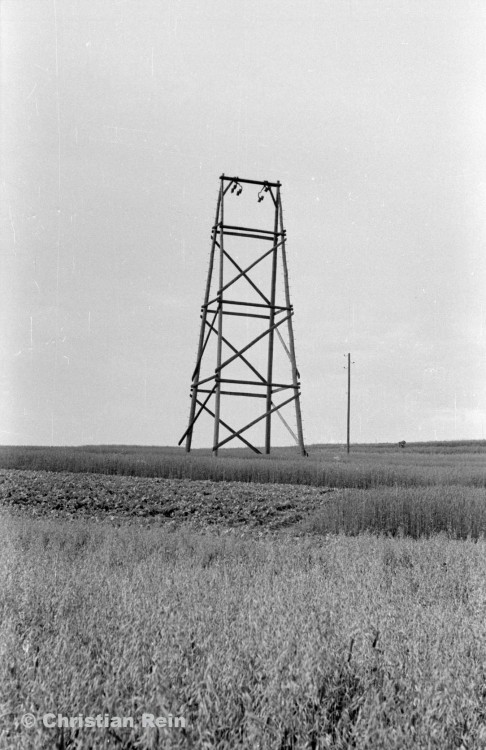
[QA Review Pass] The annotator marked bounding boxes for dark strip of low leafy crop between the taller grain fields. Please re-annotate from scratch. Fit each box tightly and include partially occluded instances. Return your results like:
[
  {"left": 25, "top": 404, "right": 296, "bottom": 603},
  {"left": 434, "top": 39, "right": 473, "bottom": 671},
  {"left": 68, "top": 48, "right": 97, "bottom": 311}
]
[{"left": 0, "top": 470, "right": 333, "bottom": 533}]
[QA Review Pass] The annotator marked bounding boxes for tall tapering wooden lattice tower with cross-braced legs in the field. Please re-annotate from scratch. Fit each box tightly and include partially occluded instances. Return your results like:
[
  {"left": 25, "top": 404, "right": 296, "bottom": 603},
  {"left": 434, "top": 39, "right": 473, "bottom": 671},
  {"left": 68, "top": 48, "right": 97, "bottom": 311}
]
[{"left": 179, "top": 175, "right": 307, "bottom": 455}]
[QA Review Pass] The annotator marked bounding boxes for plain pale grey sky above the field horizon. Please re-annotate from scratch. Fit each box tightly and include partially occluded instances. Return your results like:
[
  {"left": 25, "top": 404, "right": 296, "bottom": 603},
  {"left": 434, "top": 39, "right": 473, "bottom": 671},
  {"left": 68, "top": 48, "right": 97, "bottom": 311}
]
[{"left": 0, "top": 0, "right": 486, "bottom": 446}]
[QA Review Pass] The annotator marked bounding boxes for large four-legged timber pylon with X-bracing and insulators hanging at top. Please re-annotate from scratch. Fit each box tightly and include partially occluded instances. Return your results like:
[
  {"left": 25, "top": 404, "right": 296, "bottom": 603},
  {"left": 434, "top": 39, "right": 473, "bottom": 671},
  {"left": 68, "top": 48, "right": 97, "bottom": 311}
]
[{"left": 179, "top": 174, "right": 307, "bottom": 457}]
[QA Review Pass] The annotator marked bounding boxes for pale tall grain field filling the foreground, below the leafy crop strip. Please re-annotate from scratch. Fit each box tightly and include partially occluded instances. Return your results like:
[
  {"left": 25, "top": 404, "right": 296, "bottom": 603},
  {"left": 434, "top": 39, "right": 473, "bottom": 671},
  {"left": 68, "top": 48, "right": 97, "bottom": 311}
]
[{"left": 0, "top": 513, "right": 486, "bottom": 750}]
